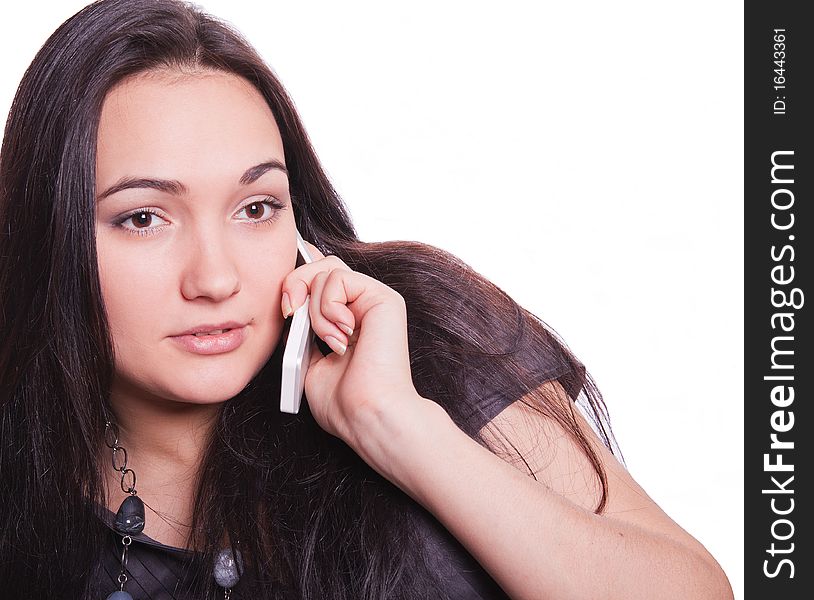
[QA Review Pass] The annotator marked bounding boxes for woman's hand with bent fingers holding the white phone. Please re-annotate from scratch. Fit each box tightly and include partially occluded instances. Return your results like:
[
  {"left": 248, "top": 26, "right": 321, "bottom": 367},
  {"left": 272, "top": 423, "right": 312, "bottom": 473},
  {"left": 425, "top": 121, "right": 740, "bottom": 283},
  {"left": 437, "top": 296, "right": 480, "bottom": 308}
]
[{"left": 282, "top": 242, "right": 419, "bottom": 446}]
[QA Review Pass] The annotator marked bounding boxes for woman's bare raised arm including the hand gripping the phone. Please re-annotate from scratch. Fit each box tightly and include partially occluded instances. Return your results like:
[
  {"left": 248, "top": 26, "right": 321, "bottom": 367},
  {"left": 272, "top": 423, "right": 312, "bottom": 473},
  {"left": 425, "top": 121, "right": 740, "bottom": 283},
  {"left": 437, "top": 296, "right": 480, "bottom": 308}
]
[{"left": 281, "top": 245, "right": 732, "bottom": 600}]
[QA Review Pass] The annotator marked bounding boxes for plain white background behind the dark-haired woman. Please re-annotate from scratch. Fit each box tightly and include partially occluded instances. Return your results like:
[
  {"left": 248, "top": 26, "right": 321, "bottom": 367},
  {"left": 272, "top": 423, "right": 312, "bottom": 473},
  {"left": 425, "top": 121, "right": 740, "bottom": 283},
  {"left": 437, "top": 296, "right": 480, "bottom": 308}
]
[{"left": 0, "top": 0, "right": 743, "bottom": 598}]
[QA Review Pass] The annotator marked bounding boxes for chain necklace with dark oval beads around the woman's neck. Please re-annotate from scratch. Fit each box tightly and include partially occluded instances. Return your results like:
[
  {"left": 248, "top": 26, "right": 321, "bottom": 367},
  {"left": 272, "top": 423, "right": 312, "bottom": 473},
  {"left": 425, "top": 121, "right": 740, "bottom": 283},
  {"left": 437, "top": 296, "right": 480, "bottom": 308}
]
[{"left": 105, "top": 421, "right": 243, "bottom": 600}]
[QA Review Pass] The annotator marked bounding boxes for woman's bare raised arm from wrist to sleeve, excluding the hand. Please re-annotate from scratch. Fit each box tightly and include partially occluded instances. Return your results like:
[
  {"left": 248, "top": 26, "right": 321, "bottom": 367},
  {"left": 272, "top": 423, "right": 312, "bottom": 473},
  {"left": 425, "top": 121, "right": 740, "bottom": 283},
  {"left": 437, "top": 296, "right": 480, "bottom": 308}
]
[{"left": 351, "top": 382, "right": 732, "bottom": 600}]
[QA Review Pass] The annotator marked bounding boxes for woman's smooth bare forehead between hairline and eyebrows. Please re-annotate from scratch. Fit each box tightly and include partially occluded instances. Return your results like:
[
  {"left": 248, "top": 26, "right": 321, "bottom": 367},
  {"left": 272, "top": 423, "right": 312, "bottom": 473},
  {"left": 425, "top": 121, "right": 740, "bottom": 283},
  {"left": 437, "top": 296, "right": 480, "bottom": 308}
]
[{"left": 97, "top": 71, "right": 284, "bottom": 190}]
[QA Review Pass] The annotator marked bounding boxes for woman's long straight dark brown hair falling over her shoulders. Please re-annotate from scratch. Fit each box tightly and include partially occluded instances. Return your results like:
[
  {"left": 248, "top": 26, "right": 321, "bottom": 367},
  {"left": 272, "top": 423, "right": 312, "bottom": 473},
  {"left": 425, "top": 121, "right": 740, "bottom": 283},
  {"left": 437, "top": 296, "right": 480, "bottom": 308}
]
[{"left": 0, "top": 0, "right": 611, "bottom": 599}]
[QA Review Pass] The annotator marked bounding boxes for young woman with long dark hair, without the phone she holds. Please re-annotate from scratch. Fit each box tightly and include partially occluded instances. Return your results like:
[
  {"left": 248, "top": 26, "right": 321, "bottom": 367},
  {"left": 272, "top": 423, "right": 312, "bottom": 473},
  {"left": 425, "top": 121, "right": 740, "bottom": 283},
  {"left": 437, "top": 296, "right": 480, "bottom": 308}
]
[{"left": 0, "top": 0, "right": 731, "bottom": 599}]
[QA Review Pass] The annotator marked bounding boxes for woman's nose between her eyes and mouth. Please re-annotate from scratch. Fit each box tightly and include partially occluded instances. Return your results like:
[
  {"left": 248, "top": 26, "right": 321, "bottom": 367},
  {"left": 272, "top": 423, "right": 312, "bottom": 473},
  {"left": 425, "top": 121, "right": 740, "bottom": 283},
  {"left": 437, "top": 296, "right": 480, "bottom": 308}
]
[{"left": 181, "top": 230, "right": 240, "bottom": 302}]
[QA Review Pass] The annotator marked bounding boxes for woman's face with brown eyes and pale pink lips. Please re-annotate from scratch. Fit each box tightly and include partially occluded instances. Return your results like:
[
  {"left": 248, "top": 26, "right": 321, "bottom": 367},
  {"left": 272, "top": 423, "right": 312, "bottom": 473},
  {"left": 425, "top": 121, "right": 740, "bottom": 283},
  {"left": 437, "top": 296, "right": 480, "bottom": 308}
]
[{"left": 96, "top": 71, "right": 297, "bottom": 404}]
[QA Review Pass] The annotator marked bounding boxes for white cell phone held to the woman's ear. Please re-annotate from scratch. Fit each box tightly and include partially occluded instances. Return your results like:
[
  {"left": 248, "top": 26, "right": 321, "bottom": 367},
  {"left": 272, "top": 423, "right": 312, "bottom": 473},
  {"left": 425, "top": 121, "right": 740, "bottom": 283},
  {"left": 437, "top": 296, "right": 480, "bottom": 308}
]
[{"left": 280, "top": 231, "right": 314, "bottom": 414}]
